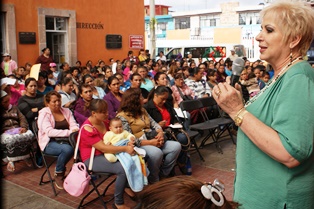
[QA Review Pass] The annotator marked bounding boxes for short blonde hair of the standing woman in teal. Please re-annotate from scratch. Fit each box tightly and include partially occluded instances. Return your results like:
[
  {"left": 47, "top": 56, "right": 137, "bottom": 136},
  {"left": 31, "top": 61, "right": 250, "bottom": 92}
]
[{"left": 260, "top": 0, "right": 314, "bottom": 56}]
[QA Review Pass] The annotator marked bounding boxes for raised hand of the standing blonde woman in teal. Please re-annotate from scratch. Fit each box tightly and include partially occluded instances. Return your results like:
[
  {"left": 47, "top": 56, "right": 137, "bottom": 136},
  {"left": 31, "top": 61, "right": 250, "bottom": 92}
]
[{"left": 212, "top": 83, "right": 244, "bottom": 118}]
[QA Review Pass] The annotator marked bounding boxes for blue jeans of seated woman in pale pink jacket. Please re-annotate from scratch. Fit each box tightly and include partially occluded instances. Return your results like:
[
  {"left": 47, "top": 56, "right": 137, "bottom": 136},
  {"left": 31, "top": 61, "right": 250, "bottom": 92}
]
[{"left": 44, "top": 141, "right": 73, "bottom": 173}]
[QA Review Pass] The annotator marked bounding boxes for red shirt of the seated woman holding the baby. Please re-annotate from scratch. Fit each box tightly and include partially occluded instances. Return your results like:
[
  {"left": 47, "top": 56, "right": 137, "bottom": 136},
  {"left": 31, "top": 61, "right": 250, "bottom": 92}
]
[{"left": 79, "top": 119, "right": 108, "bottom": 162}]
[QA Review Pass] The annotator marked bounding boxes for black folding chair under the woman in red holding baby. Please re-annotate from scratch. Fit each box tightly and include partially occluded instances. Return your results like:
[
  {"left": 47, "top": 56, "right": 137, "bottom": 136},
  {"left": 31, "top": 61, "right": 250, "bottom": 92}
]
[{"left": 69, "top": 132, "right": 116, "bottom": 208}]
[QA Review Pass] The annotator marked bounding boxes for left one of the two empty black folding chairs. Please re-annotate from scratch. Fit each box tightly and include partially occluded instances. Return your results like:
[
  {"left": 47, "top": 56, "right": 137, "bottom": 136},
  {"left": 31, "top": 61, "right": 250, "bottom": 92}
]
[{"left": 180, "top": 100, "right": 221, "bottom": 156}]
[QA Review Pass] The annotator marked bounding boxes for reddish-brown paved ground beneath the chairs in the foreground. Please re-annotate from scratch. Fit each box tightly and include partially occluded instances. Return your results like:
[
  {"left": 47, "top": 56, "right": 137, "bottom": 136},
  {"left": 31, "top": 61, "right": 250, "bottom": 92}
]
[{"left": 1, "top": 133, "right": 235, "bottom": 209}]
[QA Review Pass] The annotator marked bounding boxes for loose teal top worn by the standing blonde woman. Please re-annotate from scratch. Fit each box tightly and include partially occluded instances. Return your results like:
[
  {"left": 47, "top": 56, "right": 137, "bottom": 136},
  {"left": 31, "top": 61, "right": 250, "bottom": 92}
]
[{"left": 234, "top": 61, "right": 314, "bottom": 209}]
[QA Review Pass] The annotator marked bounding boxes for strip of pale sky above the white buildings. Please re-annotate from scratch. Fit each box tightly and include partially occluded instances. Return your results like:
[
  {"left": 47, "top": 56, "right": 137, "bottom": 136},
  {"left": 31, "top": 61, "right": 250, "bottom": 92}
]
[{"left": 144, "top": 0, "right": 265, "bottom": 12}]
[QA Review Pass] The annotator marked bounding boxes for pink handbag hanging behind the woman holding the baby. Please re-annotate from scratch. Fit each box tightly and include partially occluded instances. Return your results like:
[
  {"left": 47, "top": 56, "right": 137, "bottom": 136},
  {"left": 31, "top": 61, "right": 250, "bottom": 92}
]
[{"left": 63, "top": 162, "right": 90, "bottom": 197}]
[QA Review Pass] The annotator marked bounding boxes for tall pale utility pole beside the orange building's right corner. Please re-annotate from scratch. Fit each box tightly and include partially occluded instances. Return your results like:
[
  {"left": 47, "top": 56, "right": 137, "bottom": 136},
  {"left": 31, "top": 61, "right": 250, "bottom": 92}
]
[{"left": 149, "top": 0, "right": 156, "bottom": 59}]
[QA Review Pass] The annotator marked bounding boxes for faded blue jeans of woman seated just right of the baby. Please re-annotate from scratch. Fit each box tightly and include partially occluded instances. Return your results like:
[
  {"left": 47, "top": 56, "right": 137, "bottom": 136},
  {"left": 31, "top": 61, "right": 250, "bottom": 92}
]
[{"left": 141, "top": 141, "right": 181, "bottom": 183}]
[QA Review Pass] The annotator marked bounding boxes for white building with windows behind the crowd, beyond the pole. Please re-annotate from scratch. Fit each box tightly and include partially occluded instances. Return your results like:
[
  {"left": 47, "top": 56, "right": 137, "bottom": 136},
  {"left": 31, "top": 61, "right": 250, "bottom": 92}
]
[{"left": 145, "top": 0, "right": 313, "bottom": 61}]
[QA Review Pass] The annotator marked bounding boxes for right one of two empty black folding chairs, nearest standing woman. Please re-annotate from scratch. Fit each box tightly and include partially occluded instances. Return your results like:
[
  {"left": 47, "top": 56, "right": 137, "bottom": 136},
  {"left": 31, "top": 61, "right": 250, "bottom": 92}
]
[{"left": 199, "top": 97, "right": 235, "bottom": 153}]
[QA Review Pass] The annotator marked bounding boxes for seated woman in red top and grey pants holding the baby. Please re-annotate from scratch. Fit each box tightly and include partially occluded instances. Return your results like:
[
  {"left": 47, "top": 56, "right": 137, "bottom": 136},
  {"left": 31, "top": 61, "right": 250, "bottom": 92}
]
[{"left": 79, "top": 99, "right": 135, "bottom": 209}]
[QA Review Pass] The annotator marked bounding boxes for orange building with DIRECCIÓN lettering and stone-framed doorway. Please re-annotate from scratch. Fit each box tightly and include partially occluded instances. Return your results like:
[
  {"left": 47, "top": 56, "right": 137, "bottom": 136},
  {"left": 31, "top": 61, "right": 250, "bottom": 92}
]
[{"left": 0, "top": 0, "right": 144, "bottom": 65}]
